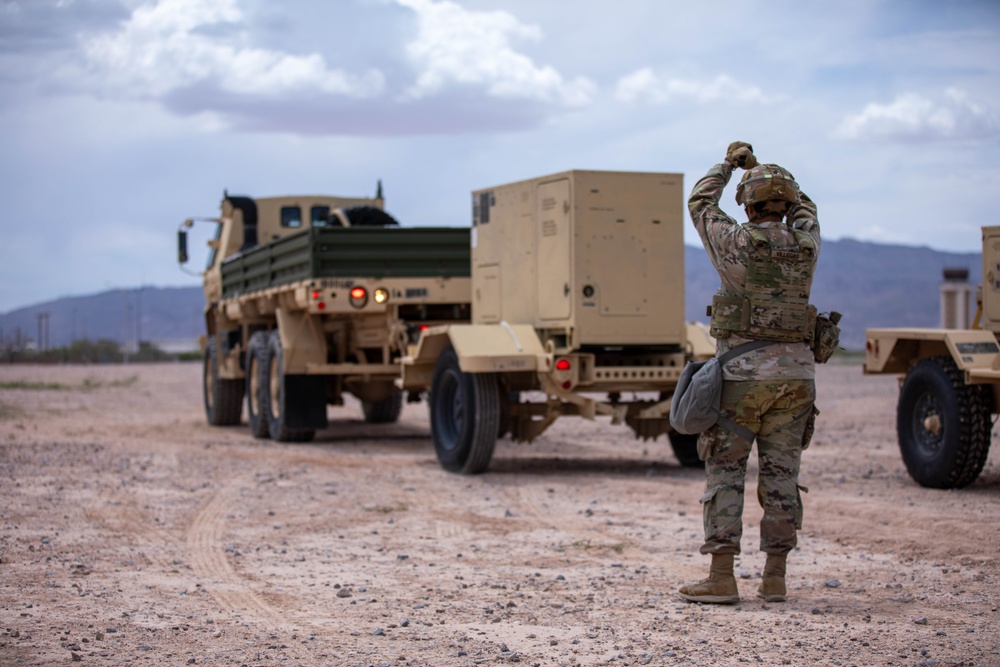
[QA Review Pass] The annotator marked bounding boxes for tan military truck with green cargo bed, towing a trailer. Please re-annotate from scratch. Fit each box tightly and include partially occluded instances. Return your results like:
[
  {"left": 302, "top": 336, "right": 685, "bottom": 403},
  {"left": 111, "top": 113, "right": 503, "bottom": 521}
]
[{"left": 179, "top": 186, "right": 470, "bottom": 441}]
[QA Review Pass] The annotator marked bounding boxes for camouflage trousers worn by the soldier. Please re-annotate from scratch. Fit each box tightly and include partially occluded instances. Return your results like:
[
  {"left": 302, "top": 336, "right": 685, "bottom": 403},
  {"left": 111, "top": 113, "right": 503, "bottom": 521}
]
[{"left": 698, "top": 380, "right": 816, "bottom": 554}]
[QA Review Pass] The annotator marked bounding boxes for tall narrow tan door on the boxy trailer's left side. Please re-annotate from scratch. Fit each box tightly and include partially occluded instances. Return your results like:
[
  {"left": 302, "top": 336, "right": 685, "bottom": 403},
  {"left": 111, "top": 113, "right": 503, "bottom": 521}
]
[{"left": 535, "top": 178, "right": 573, "bottom": 320}]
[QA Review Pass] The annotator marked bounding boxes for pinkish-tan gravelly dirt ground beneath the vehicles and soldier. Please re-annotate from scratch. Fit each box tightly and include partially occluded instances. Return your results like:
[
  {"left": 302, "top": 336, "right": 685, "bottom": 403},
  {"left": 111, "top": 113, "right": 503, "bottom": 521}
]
[{"left": 0, "top": 364, "right": 1000, "bottom": 666}]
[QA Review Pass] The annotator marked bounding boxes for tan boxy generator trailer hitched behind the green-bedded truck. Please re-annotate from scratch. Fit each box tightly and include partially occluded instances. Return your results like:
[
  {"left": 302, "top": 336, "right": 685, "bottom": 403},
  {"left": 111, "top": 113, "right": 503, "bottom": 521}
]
[{"left": 400, "top": 171, "right": 715, "bottom": 474}]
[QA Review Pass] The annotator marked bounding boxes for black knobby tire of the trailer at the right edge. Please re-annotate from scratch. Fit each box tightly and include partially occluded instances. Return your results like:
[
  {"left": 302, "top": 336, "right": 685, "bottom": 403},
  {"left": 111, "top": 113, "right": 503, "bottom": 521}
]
[{"left": 896, "top": 356, "right": 992, "bottom": 489}]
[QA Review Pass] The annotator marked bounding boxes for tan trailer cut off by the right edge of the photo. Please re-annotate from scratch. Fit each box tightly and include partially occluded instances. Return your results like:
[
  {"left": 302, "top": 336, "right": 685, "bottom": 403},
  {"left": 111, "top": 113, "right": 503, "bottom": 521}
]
[{"left": 864, "top": 226, "right": 1000, "bottom": 489}]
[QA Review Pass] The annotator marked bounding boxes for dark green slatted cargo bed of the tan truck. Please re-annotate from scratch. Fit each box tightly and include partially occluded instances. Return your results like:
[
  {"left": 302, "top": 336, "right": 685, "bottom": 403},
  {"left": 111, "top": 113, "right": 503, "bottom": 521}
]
[{"left": 222, "top": 227, "right": 471, "bottom": 298}]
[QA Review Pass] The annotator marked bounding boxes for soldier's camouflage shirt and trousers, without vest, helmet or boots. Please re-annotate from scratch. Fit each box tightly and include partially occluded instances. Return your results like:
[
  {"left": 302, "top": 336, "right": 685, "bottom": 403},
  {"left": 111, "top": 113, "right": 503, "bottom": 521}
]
[{"left": 688, "top": 162, "right": 820, "bottom": 554}]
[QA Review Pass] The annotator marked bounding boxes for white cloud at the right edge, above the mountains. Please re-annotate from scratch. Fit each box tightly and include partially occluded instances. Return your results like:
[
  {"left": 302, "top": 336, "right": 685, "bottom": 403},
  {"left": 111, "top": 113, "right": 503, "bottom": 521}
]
[{"left": 836, "top": 88, "right": 1000, "bottom": 142}]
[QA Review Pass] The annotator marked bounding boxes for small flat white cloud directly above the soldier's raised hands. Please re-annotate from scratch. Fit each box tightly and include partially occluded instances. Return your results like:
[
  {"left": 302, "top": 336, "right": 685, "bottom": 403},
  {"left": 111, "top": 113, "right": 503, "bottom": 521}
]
[{"left": 615, "top": 67, "right": 779, "bottom": 105}]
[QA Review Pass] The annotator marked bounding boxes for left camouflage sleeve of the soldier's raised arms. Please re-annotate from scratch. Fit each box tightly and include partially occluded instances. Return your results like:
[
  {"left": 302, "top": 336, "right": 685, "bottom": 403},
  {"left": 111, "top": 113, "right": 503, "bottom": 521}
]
[{"left": 688, "top": 162, "right": 747, "bottom": 274}]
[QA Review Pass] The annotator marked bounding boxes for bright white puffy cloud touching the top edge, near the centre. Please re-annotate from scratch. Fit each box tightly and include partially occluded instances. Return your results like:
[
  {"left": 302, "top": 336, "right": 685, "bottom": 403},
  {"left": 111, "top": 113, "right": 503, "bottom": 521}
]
[{"left": 396, "top": 0, "right": 596, "bottom": 106}]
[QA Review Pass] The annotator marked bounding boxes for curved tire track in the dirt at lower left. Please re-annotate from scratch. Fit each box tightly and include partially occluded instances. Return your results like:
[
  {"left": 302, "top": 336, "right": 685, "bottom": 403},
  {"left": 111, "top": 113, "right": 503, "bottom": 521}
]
[{"left": 187, "top": 482, "right": 289, "bottom": 625}]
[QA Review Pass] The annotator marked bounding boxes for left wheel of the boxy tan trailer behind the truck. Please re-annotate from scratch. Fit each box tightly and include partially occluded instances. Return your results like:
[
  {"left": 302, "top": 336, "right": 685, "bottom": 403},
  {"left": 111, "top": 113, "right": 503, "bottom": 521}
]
[{"left": 428, "top": 346, "right": 500, "bottom": 475}]
